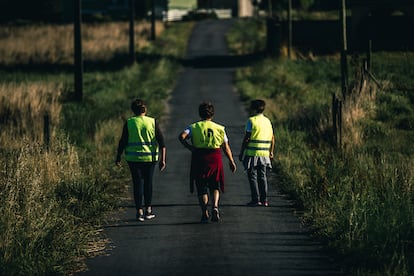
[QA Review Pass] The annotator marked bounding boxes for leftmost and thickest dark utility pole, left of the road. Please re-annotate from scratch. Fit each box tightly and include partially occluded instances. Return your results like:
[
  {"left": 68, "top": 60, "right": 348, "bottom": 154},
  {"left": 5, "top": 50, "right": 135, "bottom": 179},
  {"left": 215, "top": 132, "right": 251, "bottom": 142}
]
[{"left": 74, "top": 0, "right": 83, "bottom": 101}]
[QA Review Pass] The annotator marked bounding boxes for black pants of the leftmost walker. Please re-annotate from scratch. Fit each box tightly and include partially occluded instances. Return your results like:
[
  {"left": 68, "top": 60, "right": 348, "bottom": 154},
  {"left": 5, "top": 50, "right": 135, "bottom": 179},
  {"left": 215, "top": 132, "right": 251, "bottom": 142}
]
[{"left": 128, "top": 162, "right": 156, "bottom": 210}]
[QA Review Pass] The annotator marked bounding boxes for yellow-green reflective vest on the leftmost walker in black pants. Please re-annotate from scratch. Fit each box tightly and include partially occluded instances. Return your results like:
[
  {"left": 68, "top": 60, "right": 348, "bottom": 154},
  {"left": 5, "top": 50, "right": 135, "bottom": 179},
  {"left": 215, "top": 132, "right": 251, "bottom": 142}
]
[{"left": 125, "top": 116, "right": 158, "bottom": 162}]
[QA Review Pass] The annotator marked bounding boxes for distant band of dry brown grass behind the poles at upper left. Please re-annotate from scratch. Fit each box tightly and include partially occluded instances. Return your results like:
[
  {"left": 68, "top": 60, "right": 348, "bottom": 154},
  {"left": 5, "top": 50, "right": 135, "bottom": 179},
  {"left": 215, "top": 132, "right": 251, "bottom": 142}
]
[{"left": 0, "top": 21, "right": 164, "bottom": 65}]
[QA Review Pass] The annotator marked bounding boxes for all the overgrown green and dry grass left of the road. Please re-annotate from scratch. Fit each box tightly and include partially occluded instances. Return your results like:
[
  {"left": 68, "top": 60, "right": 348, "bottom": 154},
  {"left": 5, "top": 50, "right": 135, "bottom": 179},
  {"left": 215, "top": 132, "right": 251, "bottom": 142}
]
[{"left": 0, "top": 22, "right": 192, "bottom": 275}]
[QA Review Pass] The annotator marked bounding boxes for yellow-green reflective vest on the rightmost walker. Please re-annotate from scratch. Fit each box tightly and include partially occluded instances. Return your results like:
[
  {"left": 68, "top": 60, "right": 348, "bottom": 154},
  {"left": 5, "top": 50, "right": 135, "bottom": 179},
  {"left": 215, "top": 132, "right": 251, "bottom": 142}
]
[{"left": 245, "top": 114, "right": 273, "bottom": 156}]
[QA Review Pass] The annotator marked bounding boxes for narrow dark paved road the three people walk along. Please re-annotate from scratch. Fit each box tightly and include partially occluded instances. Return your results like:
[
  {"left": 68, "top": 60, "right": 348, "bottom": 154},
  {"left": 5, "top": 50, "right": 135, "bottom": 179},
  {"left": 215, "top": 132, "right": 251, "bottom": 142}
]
[{"left": 82, "top": 20, "right": 338, "bottom": 276}]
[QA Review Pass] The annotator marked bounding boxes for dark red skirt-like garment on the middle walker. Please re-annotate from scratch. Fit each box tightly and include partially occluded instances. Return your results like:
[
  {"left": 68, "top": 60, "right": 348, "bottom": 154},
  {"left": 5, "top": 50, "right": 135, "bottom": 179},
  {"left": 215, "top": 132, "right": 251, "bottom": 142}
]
[{"left": 190, "top": 149, "right": 224, "bottom": 193}]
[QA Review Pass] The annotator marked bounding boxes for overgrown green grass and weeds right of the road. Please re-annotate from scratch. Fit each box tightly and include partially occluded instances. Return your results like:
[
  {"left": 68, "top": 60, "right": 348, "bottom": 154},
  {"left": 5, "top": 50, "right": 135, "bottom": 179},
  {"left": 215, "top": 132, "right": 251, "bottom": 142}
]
[{"left": 229, "top": 20, "right": 414, "bottom": 275}]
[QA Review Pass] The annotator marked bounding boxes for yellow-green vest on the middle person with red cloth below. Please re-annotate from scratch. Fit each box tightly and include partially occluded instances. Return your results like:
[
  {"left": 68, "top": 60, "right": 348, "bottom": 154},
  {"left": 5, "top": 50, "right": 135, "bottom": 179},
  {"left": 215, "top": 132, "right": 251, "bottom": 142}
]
[{"left": 190, "top": 120, "right": 224, "bottom": 149}]
